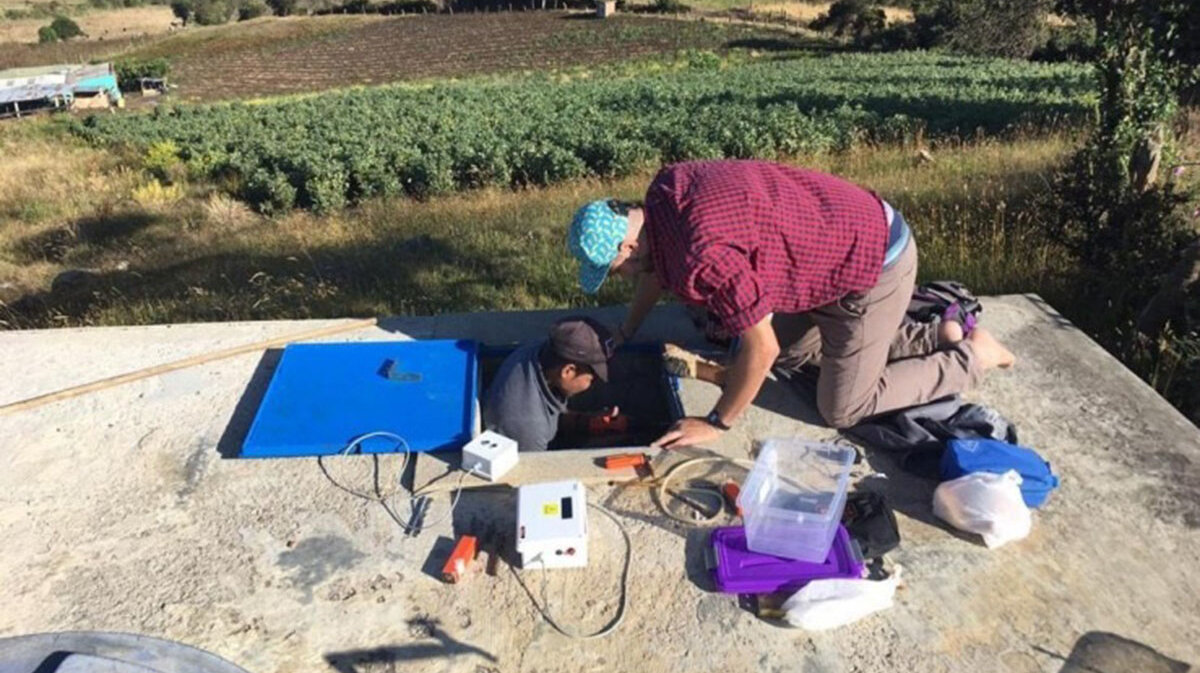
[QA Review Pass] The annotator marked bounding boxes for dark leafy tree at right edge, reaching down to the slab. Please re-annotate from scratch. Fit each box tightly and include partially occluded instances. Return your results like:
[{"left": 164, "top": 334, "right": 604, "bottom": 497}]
[{"left": 1055, "top": 0, "right": 1200, "bottom": 422}]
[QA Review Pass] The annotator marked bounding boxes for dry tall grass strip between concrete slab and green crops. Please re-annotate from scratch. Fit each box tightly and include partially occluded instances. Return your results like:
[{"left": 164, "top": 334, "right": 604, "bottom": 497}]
[{"left": 0, "top": 121, "right": 1074, "bottom": 328}]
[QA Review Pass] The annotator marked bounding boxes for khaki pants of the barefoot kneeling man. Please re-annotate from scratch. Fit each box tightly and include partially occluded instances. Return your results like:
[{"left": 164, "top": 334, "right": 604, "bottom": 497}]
[{"left": 772, "top": 236, "right": 982, "bottom": 428}]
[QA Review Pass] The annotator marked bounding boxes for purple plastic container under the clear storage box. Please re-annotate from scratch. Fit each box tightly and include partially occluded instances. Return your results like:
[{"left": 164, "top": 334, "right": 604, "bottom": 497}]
[{"left": 707, "top": 524, "right": 865, "bottom": 594}]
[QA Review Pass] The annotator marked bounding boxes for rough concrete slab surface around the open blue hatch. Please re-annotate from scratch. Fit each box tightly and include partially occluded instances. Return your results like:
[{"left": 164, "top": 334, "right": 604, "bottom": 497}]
[{"left": 0, "top": 296, "right": 1200, "bottom": 673}]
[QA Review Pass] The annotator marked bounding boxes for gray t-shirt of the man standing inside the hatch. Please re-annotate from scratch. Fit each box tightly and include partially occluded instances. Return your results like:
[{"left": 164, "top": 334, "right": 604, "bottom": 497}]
[{"left": 484, "top": 341, "right": 566, "bottom": 451}]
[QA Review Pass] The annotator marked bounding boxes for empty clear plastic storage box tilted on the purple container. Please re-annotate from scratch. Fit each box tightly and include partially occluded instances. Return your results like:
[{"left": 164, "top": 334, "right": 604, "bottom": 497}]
[{"left": 738, "top": 439, "right": 854, "bottom": 563}]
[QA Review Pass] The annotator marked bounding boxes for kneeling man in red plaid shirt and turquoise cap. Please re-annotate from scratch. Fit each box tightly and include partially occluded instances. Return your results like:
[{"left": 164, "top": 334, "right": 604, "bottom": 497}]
[{"left": 568, "top": 161, "right": 1013, "bottom": 447}]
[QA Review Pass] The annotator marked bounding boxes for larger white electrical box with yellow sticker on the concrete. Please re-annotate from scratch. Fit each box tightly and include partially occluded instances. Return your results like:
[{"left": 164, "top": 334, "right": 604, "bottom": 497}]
[{"left": 516, "top": 481, "right": 588, "bottom": 569}]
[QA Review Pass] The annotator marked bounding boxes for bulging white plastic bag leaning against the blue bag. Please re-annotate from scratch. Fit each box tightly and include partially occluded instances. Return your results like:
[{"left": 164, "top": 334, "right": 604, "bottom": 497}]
[{"left": 934, "top": 470, "right": 1033, "bottom": 547}]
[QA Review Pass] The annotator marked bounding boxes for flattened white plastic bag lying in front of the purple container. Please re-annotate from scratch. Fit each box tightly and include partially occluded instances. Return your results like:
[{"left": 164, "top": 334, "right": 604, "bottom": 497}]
[{"left": 784, "top": 566, "right": 901, "bottom": 631}]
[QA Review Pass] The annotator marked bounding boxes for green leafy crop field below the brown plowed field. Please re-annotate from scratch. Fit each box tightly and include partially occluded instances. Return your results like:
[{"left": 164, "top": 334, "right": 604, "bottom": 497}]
[{"left": 77, "top": 53, "right": 1091, "bottom": 212}]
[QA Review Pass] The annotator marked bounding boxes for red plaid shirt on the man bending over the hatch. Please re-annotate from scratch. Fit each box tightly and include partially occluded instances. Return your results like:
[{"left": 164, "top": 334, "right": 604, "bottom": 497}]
[{"left": 646, "top": 161, "right": 888, "bottom": 335}]
